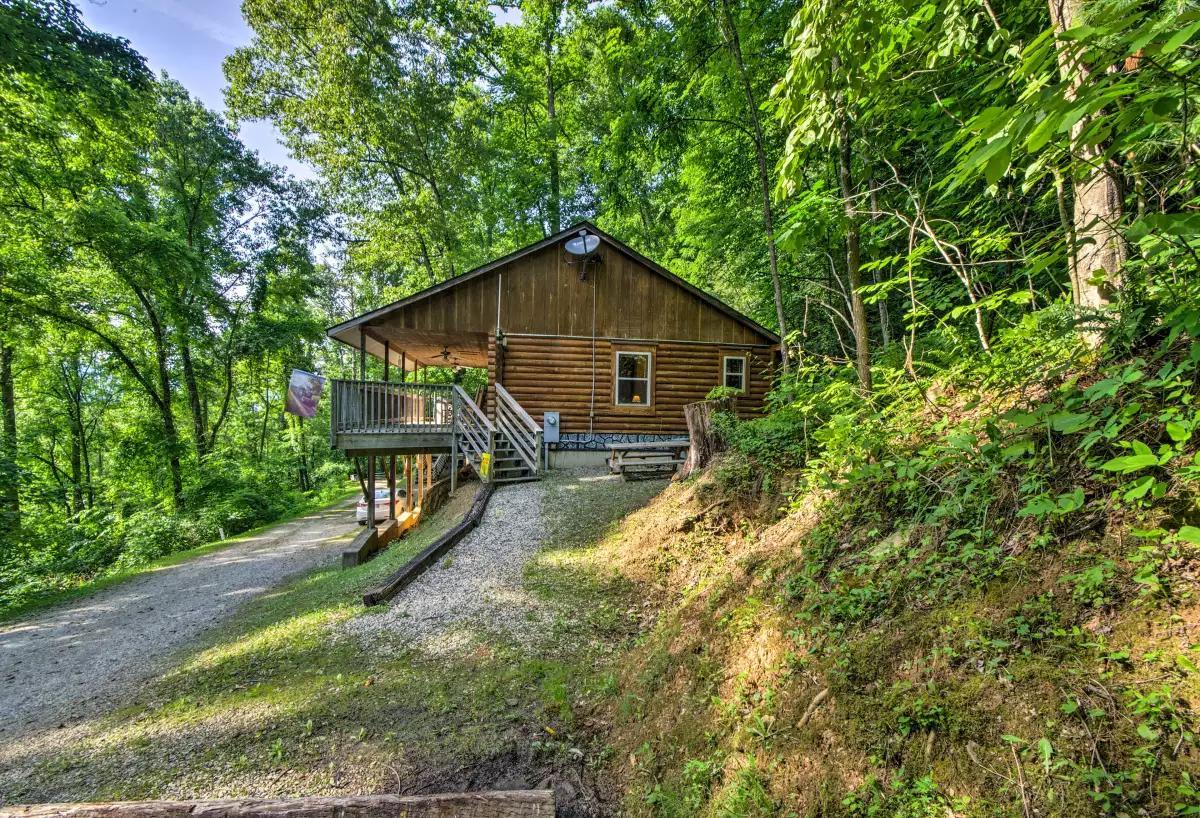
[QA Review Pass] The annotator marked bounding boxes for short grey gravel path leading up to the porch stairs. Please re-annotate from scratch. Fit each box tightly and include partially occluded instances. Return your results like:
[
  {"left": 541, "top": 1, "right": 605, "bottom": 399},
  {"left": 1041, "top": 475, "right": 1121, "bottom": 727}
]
[{"left": 344, "top": 482, "right": 548, "bottom": 654}]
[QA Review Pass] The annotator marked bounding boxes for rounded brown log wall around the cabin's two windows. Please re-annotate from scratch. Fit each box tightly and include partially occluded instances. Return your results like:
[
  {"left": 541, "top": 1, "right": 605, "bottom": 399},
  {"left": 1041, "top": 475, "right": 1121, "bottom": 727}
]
[{"left": 488, "top": 335, "right": 774, "bottom": 434}]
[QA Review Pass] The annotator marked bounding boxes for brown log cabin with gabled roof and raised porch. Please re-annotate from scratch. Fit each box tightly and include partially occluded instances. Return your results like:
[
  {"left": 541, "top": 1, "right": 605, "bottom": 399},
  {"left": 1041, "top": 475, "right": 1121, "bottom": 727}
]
[{"left": 328, "top": 222, "right": 780, "bottom": 481}]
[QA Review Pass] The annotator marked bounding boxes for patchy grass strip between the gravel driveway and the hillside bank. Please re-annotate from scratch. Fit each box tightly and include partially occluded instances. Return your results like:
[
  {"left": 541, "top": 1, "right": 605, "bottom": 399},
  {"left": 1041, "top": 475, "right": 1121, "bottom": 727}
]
[{"left": 0, "top": 465, "right": 661, "bottom": 801}]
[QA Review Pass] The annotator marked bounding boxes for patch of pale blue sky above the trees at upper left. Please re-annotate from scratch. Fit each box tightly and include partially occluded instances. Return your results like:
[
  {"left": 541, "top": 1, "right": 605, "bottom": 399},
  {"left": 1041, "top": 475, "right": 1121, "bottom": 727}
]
[{"left": 76, "top": 0, "right": 314, "bottom": 179}]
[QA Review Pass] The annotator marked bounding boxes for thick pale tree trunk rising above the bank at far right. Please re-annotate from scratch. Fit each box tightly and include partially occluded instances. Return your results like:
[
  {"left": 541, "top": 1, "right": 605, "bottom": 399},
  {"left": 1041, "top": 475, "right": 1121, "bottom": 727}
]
[{"left": 1049, "top": 0, "right": 1126, "bottom": 323}]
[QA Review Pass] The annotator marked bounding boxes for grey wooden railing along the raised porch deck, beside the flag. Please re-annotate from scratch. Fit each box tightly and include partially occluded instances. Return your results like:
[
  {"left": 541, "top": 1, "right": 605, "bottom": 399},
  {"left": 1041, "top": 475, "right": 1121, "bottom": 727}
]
[{"left": 331, "top": 379, "right": 455, "bottom": 435}]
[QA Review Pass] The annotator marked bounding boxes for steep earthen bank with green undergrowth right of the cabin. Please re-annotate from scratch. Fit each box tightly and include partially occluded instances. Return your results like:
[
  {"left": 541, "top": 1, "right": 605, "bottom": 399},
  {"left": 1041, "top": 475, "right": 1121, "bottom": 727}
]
[{"left": 588, "top": 323, "right": 1200, "bottom": 817}]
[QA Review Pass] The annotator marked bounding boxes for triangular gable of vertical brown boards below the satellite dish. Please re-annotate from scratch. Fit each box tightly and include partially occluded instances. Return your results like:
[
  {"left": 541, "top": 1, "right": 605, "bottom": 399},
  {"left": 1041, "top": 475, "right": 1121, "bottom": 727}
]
[{"left": 367, "top": 237, "right": 768, "bottom": 347}]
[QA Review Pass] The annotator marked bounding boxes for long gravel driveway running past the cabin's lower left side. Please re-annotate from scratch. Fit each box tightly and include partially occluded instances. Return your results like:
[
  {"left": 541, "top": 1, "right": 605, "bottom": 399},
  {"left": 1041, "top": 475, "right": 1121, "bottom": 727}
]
[{"left": 0, "top": 496, "right": 358, "bottom": 745}]
